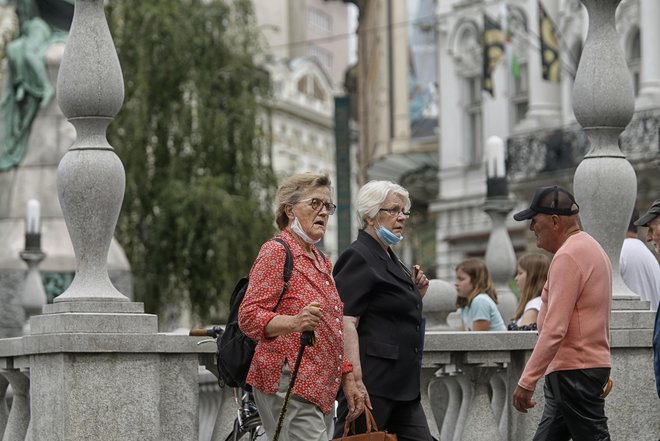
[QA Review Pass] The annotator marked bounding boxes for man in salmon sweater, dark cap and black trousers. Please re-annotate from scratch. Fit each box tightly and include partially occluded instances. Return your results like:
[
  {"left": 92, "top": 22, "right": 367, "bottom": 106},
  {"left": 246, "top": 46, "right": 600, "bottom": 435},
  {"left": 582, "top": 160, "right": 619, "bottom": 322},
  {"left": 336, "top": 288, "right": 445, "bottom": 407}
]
[{"left": 513, "top": 186, "right": 612, "bottom": 441}]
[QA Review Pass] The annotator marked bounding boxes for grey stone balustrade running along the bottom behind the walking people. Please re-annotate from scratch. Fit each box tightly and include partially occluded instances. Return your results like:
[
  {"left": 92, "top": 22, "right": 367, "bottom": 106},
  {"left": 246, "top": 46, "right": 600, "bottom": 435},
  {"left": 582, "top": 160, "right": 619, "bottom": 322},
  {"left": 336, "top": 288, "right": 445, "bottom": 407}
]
[{"left": 0, "top": 300, "right": 660, "bottom": 441}]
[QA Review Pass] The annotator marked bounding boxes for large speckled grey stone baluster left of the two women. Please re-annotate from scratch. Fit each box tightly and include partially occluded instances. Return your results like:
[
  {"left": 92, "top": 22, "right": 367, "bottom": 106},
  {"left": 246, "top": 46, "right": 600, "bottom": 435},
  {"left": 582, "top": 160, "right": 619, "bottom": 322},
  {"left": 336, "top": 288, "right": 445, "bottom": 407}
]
[{"left": 55, "top": 0, "right": 129, "bottom": 302}]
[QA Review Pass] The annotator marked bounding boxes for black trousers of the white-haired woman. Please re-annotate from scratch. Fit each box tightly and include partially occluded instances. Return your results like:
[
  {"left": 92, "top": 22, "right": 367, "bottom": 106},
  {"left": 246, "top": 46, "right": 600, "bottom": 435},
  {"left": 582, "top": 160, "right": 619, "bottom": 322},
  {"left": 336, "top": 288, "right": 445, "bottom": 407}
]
[{"left": 334, "top": 390, "right": 433, "bottom": 441}]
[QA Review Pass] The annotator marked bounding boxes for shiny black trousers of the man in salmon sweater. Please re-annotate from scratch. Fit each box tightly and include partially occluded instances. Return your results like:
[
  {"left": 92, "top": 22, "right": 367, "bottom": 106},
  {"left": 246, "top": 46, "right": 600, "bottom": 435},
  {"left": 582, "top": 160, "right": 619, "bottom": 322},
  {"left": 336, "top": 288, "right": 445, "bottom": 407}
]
[{"left": 534, "top": 368, "right": 610, "bottom": 441}]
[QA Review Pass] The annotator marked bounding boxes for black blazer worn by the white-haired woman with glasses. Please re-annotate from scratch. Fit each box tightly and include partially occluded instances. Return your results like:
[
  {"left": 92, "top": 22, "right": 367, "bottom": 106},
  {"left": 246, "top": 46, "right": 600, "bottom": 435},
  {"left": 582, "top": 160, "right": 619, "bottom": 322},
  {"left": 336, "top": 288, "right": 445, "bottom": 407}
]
[{"left": 332, "top": 230, "right": 423, "bottom": 401}]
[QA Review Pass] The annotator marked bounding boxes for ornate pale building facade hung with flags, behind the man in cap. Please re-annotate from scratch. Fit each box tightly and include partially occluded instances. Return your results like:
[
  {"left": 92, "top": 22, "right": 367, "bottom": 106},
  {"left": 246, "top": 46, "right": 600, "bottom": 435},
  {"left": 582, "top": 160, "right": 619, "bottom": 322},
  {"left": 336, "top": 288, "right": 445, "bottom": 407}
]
[{"left": 431, "top": 0, "right": 660, "bottom": 277}]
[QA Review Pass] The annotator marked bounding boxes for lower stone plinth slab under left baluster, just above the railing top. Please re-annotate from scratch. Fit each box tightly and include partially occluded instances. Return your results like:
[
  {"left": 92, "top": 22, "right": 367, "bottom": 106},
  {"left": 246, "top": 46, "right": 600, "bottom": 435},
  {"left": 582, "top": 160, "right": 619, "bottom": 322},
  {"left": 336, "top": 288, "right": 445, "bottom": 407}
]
[{"left": 30, "top": 313, "right": 158, "bottom": 335}]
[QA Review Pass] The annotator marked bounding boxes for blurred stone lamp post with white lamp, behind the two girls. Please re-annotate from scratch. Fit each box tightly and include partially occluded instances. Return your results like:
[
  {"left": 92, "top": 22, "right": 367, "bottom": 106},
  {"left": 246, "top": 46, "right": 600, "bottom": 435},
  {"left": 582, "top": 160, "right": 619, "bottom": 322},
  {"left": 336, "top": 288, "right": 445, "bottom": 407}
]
[{"left": 482, "top": 136, "right": 518, "bottom": 323}]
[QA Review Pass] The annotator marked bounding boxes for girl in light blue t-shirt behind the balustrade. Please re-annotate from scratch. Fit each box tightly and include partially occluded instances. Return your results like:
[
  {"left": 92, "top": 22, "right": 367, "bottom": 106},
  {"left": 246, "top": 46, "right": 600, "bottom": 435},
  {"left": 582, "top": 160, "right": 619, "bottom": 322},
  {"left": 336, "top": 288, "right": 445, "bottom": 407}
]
[{"left": 455, "top": 259, "right": 506, "bottom": 331}]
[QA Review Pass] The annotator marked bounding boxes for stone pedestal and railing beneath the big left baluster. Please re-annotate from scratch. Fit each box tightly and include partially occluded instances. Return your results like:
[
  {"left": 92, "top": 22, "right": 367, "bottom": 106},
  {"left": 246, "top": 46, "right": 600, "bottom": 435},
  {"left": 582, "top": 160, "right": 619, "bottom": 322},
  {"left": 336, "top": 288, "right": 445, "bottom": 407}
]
[{"left": 0, "top": 326, "right": 204, "bottom": 441}]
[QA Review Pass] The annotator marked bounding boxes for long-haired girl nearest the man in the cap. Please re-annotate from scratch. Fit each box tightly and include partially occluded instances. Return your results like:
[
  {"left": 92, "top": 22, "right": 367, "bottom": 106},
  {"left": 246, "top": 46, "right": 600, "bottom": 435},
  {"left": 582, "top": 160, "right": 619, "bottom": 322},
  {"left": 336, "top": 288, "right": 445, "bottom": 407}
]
[{"left": 508, "top": 253, "right": 550, "bottom": 331}]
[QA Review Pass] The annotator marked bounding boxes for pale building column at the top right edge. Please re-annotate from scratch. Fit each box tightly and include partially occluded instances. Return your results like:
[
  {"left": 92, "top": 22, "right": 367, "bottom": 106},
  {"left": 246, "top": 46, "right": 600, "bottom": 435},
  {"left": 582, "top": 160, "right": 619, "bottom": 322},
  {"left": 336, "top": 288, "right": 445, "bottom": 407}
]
[{"left": 637, "top": 0, "right": 660, "bottom": 109}]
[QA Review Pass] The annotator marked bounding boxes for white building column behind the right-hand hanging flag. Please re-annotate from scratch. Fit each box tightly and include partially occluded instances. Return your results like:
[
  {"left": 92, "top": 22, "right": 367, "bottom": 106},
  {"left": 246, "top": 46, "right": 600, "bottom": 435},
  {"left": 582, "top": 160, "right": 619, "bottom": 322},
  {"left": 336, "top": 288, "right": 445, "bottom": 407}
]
[{"left": 517, "top": 0, "right": 561, "bottom": 130}]
